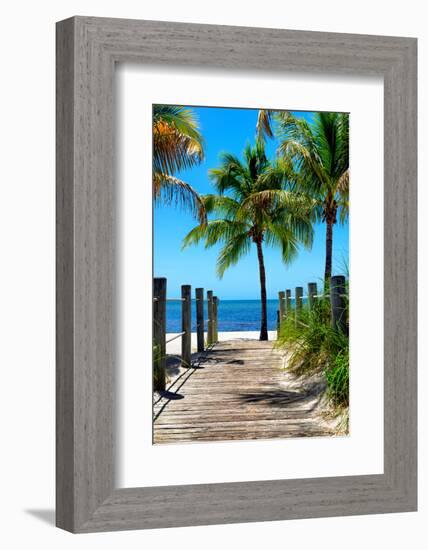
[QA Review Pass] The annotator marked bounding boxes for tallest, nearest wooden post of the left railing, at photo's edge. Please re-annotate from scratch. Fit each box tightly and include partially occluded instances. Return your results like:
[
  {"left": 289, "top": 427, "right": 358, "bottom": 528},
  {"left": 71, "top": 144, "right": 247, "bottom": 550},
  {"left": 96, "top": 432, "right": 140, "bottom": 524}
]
[{"left": 153, "top": 277, "right": 166, "bottom": 391}]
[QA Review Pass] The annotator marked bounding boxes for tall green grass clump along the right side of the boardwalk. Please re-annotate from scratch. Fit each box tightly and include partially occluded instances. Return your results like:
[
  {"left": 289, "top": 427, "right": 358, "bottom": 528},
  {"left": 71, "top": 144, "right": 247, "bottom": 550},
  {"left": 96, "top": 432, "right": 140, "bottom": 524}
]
[{"left": 277, "top": 297, "right": 349, "bottom": 408}]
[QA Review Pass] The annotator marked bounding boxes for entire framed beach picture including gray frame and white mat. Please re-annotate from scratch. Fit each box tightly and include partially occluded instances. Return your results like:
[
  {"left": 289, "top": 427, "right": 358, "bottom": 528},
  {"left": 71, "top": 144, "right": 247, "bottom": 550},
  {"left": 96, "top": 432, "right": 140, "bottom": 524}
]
[{"left": 57, "top": 17, "right": 417, "bottom": 533}]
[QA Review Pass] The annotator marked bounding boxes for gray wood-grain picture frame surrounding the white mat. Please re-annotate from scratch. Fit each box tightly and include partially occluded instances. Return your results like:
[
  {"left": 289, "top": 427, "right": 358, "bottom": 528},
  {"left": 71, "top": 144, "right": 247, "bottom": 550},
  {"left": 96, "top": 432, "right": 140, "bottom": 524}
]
[{"left": 56, "top": 17, "right": 417, "bottom": 532}]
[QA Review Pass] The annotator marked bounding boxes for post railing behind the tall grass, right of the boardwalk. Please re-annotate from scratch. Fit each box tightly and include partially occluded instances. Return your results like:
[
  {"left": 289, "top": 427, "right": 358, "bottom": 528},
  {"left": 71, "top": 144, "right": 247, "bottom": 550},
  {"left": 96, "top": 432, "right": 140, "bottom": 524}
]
[{"left": 277, "top": 275, "right": 347, "bottom": 332}]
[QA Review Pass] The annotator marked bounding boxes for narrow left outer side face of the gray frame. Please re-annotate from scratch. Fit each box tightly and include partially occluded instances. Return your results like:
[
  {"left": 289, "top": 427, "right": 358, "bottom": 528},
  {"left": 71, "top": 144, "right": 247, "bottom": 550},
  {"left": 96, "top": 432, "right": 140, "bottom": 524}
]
[{"left": 56, "top": 18, "right": 75, "bottom": 530}]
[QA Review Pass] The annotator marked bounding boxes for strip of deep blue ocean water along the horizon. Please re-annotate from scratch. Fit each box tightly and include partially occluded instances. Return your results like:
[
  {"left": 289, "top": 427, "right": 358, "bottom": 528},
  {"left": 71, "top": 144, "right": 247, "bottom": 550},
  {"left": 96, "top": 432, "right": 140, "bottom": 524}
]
[{"left": 166, "top": 300, "right": 300, "bottom": 332}]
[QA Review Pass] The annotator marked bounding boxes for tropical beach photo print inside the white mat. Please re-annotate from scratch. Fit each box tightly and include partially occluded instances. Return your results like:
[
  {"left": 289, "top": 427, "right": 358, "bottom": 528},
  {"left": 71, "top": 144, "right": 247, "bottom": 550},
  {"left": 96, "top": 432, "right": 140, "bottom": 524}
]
[{"left": 149, "top": 102, "right": 350, "bottom": 452}]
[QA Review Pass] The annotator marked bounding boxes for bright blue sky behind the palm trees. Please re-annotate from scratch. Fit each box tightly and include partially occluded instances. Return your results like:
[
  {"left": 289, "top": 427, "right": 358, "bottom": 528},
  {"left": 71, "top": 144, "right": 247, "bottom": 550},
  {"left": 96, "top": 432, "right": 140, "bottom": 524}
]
[{"left": 154, "top": 107, "right": 349, "bottom": 300}]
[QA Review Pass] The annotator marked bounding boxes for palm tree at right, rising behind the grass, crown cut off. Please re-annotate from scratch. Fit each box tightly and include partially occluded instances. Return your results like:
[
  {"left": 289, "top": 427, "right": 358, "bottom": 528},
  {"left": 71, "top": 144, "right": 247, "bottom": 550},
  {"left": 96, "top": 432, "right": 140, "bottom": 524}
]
[{"left": 257, "top": 111, "right": 349, "bottom": 286}]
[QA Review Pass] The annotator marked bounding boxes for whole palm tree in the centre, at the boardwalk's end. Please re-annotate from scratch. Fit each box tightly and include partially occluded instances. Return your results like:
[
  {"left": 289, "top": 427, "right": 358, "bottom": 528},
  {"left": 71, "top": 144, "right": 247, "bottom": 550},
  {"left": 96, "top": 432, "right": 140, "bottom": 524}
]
[{"left": 183, "top": 142, "right": 313, "bottom": 340}]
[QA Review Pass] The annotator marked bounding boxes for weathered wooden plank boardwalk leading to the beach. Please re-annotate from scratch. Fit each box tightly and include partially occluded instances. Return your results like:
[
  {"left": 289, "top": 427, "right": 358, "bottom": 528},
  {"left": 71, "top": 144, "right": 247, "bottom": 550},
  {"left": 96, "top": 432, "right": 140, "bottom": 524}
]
[{"left": 153, "top": 339, "right": 332, "bottom": 443}]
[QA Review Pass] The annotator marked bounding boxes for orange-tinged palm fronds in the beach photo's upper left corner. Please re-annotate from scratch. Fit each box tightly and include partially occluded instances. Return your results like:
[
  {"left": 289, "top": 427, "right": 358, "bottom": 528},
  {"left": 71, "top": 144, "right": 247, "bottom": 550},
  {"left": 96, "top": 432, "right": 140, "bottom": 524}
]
[{"left": 152, "top": 105, "right": 205, "bottom": 221}]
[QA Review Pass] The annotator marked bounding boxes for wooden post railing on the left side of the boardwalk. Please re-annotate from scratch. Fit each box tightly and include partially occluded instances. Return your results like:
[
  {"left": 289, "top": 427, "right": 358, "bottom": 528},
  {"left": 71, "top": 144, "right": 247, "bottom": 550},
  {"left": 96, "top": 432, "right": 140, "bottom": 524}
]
[{"left": 153, "top": 277, "right": 219, "bottom": 391}]
